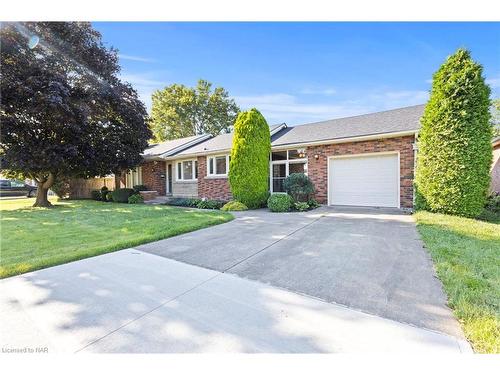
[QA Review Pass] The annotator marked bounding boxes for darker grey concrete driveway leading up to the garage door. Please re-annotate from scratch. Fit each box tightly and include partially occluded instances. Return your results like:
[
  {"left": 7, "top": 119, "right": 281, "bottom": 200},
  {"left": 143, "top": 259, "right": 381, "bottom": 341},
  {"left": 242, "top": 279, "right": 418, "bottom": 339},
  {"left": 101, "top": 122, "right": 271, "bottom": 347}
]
[{"left": 137, "top": 207, "right": 463, "bottom": 339}]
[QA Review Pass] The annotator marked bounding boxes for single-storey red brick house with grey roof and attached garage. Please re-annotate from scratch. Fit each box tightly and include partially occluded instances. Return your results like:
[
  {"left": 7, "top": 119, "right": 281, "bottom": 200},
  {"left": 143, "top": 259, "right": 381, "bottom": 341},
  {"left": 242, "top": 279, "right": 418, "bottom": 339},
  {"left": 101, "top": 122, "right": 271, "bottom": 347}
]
[{"left": 125, "top": 105, "right": 424, "bottom": 209}]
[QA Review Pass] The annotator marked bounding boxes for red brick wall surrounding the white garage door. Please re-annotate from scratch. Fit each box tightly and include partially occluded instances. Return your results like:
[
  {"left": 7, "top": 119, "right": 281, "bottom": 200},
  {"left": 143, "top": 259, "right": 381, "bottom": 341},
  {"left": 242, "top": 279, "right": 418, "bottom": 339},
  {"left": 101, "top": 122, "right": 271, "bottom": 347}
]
[{"left": 307, "top": 136, "right": 415, "bottom": 208}]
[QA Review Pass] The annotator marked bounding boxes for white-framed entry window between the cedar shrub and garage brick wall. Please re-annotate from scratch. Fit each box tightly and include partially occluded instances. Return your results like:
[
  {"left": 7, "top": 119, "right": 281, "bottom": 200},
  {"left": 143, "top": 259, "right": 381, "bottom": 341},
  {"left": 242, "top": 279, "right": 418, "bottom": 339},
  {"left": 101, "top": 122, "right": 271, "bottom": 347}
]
[{"left": 271, "top": 149, "right": 307, "bottom": 193}]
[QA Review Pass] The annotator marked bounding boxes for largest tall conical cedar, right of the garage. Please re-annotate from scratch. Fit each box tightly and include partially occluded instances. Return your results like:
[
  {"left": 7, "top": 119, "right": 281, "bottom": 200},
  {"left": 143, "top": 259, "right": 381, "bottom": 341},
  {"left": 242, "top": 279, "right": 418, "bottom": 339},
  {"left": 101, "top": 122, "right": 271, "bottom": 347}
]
[{"left": 415, "top": 49, "right": 492, "bottom": 217}]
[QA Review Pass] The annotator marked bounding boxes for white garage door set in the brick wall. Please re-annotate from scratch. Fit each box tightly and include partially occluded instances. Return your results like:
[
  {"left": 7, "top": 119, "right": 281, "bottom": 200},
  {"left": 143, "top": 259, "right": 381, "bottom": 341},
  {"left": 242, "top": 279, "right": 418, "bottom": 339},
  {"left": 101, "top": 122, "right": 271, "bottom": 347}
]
[{"left": 328, "top": 154, "right": 399, "bottom": 207}]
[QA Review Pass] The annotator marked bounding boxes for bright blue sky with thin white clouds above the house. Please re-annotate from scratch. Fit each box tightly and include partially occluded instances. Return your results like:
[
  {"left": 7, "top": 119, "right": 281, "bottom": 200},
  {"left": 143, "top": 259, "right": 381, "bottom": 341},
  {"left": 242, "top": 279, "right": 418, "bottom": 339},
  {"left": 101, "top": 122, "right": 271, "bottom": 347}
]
[{"left": 93, "top": 22, "right": 500, "bottom": 125}]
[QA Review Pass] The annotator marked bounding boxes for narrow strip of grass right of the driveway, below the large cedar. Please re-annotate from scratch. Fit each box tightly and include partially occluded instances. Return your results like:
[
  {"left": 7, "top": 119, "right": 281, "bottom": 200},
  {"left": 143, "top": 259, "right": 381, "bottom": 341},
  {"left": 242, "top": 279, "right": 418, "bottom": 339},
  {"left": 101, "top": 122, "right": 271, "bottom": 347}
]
[{"left": 415, "top": 211, "right": 500, "bottom": 353}]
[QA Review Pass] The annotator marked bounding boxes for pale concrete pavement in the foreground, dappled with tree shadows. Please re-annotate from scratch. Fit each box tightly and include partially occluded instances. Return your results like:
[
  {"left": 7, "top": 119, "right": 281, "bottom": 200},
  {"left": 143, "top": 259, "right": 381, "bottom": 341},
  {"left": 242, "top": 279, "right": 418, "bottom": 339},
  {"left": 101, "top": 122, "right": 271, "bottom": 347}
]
[{"left": 0, "top": 250, "right": 470, "bottom": 354}]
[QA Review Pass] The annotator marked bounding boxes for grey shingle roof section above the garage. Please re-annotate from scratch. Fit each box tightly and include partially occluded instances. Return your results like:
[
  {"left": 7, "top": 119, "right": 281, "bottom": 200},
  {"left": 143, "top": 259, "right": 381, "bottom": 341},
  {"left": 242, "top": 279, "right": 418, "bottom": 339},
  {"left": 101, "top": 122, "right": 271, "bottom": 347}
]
[{"left": 271, "top": 105, "right": 425, "bottom": 146}]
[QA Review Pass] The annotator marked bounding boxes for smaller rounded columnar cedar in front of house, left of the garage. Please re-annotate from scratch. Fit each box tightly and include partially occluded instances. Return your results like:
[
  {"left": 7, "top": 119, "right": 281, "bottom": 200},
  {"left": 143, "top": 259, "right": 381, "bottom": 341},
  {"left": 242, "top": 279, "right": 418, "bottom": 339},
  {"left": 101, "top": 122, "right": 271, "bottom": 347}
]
[{"left": 229, "top": 108, "right": 271, "bottom": 208}]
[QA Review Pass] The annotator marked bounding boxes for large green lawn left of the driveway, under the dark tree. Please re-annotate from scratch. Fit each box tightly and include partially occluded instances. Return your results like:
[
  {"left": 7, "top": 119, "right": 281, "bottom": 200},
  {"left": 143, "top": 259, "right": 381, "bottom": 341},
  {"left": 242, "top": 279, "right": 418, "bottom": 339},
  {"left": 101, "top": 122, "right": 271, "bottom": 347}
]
[{"left": 0, "top": 198, "right": 233, "bottom": 278}]
